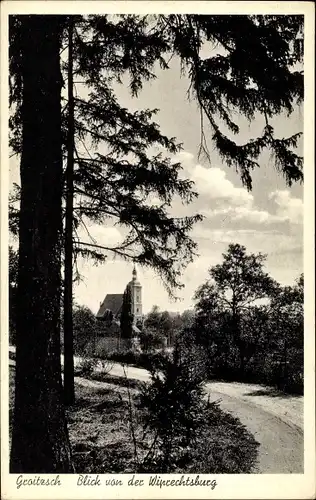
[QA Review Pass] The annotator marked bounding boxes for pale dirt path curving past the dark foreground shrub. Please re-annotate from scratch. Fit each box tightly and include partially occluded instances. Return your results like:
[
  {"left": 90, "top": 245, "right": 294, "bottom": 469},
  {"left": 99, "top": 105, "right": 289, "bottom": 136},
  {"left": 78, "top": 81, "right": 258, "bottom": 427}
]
[{"left": 74, "top": 364, "right": 304, "bottom": 474}]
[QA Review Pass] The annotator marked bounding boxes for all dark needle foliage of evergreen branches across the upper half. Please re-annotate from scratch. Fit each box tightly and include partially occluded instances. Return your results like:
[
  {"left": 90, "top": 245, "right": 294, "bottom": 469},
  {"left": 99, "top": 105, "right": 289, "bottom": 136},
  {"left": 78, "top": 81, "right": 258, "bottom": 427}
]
[{"left": 10, "top": 14, "right": 304, "bottom": 292}]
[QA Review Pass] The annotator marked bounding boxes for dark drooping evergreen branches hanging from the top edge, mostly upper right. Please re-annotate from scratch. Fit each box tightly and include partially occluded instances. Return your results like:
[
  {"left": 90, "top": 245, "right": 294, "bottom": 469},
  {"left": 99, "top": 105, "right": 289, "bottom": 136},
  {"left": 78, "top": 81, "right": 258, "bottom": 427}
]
[{"left": 11, "top": 15, "right": 304, "bottom": 194}]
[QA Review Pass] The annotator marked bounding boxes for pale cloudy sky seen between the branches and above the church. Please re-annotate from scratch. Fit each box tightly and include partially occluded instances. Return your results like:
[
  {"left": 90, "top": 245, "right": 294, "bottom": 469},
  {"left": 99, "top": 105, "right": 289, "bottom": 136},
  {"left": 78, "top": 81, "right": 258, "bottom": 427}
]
[{"left": 10, "top": 47, "right": 303, "bottom": 313}]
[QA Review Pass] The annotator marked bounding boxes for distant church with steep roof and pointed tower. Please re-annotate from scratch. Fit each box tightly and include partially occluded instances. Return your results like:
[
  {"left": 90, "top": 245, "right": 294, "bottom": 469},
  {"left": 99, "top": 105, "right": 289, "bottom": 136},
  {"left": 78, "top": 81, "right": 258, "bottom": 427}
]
[{"left": 96, "top": 266, "right": 143, "bottom": 330}]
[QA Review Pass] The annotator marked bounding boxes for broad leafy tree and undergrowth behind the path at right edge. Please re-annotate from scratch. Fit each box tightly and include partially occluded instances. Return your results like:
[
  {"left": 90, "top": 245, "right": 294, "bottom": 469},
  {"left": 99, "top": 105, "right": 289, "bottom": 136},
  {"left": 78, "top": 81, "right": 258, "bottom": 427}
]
[{"left": 191, "top": 245, "right": 304, "bottom": 393}]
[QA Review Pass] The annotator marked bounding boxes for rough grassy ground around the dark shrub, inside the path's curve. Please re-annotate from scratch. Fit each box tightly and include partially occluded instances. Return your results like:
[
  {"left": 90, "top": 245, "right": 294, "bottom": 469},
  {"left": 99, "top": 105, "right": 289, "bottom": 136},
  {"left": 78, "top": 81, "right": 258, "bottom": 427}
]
[{"left": 68, "top": 377, "right": 258, "bottom": 474}]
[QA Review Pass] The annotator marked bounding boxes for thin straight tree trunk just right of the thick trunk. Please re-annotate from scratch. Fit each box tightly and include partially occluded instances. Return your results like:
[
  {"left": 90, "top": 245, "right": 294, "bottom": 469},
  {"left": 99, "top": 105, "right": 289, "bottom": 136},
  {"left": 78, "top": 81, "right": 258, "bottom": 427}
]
[{"left": 64, "top": 19, "right": 75, "bottom": 405}]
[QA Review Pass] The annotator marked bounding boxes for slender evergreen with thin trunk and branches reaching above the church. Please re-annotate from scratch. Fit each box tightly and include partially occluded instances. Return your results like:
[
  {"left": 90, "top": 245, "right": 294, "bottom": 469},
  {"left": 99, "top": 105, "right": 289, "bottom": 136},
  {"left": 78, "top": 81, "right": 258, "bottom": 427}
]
[{"left": 60, "top": 18, "right": 200, "bottom": 403}]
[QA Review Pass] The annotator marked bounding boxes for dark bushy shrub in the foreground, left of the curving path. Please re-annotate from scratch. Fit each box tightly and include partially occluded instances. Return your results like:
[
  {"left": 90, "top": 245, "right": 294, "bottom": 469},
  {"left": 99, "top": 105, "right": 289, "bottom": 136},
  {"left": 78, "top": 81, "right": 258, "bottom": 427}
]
[{"left": 138, "top": 346, "right": 206, "bottom": 472}]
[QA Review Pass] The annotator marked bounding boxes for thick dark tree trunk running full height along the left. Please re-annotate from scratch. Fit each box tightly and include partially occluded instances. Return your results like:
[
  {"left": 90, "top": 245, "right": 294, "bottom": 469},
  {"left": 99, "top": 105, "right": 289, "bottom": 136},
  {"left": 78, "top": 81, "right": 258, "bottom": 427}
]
[{"left": 10, "top": 15, "right": 73, "bottom": 473}]
